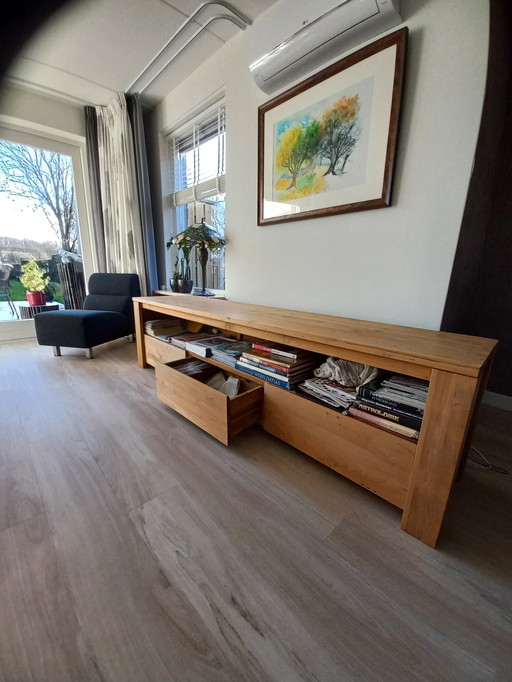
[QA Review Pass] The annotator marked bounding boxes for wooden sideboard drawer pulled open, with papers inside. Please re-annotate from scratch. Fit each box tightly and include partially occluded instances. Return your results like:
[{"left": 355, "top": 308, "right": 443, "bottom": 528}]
[{"left": 155, "top": 358, "right": 263, "bottom": 445}]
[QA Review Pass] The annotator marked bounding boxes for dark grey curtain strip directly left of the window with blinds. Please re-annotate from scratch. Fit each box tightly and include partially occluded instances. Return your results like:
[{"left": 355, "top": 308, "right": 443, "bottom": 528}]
[{"left": 126, "top": 94, "right": 158, "bottom": 292}]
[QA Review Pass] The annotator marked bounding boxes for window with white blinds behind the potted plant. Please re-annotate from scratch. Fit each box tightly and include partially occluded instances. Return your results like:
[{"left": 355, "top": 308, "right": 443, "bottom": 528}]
[{"left": 168, "top": 104, "right": 226, "bottom": 289}]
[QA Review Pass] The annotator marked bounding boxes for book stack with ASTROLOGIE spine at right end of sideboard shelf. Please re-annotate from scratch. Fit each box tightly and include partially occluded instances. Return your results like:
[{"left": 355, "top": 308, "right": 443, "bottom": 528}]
[{"left": 349, "top": 374, "right": 428, "bottom": 440}]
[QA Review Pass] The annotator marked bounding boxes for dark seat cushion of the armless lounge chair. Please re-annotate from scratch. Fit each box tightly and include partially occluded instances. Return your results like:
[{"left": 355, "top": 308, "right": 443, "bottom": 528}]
[{"left": 34, "top": 310, "right": 132, "bottom": 348}]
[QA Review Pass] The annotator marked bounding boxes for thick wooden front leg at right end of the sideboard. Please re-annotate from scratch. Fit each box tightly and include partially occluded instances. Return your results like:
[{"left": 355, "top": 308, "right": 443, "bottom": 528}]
[{"left": 401, "top": 370, "right": 479, "bottom": 547}]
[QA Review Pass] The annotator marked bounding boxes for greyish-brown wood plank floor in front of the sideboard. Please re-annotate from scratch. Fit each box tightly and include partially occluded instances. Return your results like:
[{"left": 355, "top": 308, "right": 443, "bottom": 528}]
[{"left": 0, "top": 340, "right": 512, "bottom": 682}]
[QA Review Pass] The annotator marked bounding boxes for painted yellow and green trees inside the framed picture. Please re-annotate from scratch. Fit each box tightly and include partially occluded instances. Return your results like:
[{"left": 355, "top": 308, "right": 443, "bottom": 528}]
[{"left": 274, "top": 83, "right": 364, "bottom": 201}]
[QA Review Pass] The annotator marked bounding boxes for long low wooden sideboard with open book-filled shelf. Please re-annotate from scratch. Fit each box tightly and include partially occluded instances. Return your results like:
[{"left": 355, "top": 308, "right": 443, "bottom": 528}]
[{"left": 134, "top": 295, "right": 497, "bottom": 547}]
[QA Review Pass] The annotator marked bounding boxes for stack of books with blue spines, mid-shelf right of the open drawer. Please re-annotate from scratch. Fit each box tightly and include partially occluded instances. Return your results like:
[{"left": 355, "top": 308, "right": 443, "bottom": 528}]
[{"left": 235, "top": 343, "right": 318, "bottom": 391}]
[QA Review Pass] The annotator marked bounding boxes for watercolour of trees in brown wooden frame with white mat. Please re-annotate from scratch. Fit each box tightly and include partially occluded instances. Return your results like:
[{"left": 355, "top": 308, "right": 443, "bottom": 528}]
[{"left": 258, "top": 28, "right": 407, "bottom": 225}]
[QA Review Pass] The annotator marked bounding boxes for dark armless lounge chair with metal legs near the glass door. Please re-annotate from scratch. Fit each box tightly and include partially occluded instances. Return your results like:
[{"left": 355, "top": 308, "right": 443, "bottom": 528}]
[{"left": 34, "top": 273, "right": 140, "bottom": 358}]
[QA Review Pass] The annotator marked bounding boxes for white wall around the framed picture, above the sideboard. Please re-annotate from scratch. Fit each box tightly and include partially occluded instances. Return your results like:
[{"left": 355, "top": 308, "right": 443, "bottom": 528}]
[{"left": 153, "top": 0, "right": 489, "bottom": 329}]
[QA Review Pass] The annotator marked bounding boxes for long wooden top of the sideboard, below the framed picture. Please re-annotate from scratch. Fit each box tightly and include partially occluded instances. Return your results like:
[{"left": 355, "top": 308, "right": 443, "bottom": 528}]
[{"left": 133, "top": 294, "right": 497, "bottom": 376}]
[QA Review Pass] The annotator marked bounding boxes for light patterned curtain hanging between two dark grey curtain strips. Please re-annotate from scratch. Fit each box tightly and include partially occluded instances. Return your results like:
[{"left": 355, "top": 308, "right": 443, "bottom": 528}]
[{"left": 86, "top": 93, "right": 148, "bottom": 295}]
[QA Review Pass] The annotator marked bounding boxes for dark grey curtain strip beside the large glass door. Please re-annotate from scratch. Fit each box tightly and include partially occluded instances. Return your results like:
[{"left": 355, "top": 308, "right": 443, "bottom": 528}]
[{"left": 85, "top": 107, "right": 107, "bottom": 272}]
